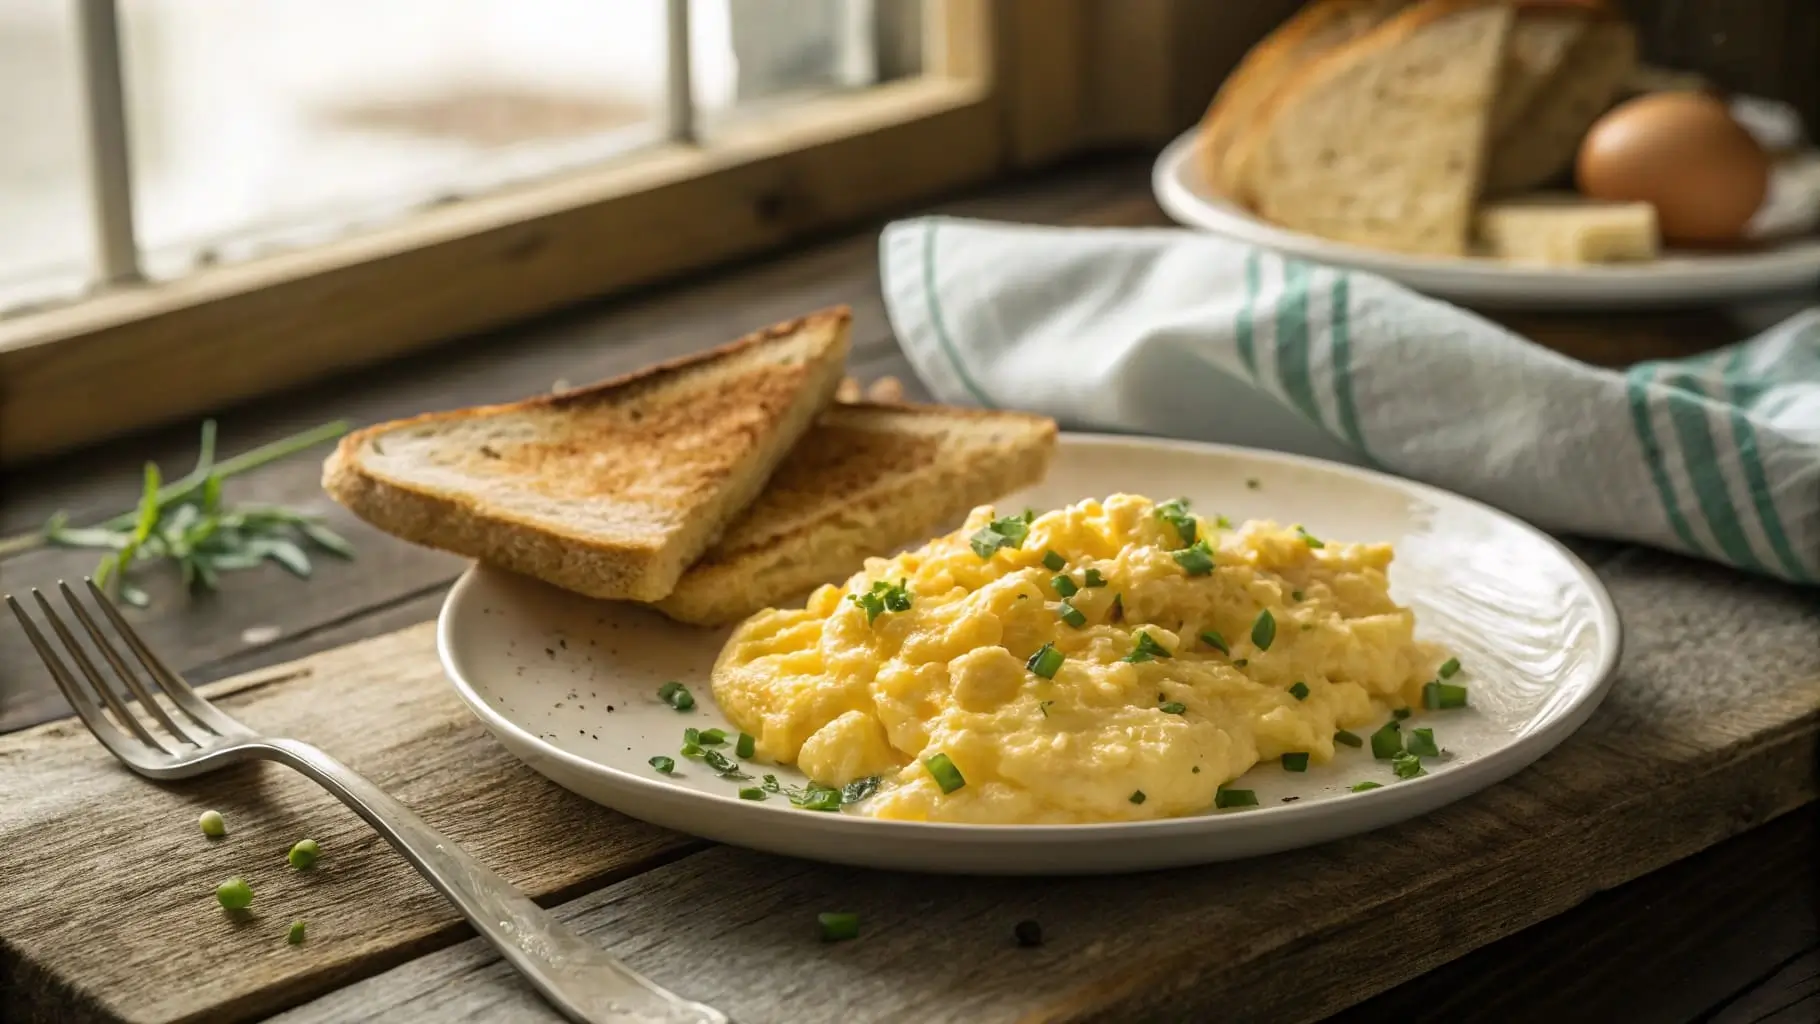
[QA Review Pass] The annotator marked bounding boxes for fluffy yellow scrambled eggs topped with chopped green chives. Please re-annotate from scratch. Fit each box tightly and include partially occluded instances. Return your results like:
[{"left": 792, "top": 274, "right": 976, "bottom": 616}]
[{"left": 713, "top": 495, "right": 1440, "bottom": 824}]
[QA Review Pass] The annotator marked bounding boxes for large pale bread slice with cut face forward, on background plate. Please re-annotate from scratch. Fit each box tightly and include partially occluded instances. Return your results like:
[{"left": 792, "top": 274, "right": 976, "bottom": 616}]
[{"left": 1243, "top": 0, "right": 1516, "bottom": 256}]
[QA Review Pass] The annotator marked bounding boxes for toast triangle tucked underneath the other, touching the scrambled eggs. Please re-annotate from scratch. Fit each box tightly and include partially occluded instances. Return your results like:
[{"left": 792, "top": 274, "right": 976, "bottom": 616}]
[{"left": 657, "top": 402, "right": 1056, "bottom": 626}]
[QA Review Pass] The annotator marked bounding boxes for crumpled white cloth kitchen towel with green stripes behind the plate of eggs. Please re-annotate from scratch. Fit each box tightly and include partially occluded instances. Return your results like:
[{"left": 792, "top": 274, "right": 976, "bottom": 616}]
[{"left": 881, "top": 216, "right": 1820, "bottom": 584}]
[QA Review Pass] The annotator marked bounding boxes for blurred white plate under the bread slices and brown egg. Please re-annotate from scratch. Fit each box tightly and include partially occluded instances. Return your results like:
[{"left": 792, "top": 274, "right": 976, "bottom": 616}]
[{"left": 1150, "top": 131, "right": 1820, "bottom": 309}]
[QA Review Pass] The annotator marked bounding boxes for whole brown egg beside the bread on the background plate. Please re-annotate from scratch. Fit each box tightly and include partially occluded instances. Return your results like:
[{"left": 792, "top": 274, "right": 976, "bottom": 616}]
[{"left": 1574, "top": 93, "right": 1769, "bottom": 244}]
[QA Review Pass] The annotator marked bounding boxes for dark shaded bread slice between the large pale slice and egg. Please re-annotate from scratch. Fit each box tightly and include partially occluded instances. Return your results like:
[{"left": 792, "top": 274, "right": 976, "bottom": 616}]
[{"left": 1485, "top": 13, "right": 1636, "bottom": 196}]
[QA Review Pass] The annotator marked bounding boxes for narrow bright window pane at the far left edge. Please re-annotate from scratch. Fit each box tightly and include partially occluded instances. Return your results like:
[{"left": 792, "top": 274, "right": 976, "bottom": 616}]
[{"left": 0, "top": 0, "right": 95, "bottom": 313}]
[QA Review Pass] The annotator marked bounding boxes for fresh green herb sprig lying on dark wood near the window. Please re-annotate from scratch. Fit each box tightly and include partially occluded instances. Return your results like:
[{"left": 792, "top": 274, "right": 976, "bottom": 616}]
[{"left": 29, "top": 420, "right": 353, "bottom": 607}]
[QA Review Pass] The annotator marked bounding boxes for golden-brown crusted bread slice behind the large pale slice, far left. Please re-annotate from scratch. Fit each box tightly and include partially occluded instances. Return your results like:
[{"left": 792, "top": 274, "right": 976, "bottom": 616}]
[{"left": 1199, "top": 0, "right": 1411, "bottom": 196}]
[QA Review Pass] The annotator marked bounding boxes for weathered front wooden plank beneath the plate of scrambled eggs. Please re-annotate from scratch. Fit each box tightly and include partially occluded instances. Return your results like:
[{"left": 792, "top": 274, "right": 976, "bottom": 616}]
[{"left": 242, "top": 555, "right": 1820, "bottom": 1024}]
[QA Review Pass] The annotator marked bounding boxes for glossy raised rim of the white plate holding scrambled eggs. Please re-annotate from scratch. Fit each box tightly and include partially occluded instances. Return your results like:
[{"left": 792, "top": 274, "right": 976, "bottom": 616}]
[{"left": 435, "top": 431, "right": 1623, "bottom": 844}]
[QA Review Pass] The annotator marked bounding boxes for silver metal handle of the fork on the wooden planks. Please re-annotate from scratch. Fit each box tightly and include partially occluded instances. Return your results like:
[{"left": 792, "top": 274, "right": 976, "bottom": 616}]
[{"left": 260, "top": 738, "right": 728, "bottom": 1024}]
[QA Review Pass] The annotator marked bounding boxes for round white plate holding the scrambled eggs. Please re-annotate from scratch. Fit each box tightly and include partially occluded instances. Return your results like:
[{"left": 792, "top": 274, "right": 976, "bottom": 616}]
[{"left": 437, "top": 435, "right": 1620, "bottom": 875}]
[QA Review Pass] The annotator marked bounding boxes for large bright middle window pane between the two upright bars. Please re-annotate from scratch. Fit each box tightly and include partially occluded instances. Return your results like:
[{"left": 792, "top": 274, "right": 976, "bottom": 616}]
[{"left": 121, "top": 0, "right": 664, "bottom": 276}]
